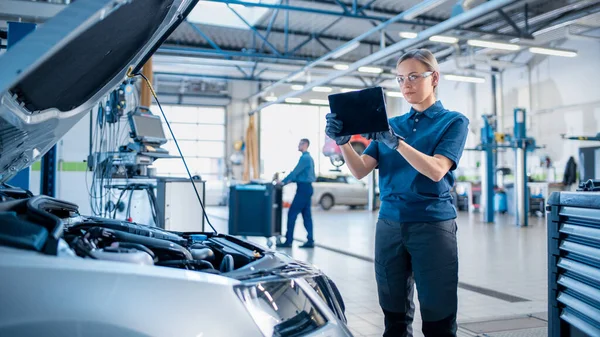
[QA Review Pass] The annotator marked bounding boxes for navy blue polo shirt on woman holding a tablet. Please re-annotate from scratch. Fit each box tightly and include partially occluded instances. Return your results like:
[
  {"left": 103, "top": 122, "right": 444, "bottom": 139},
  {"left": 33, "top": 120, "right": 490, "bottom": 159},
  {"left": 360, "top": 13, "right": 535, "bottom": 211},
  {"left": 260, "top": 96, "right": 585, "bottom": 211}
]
[{"left": 364, "top": 101, "right": 469, "bottom": 222}]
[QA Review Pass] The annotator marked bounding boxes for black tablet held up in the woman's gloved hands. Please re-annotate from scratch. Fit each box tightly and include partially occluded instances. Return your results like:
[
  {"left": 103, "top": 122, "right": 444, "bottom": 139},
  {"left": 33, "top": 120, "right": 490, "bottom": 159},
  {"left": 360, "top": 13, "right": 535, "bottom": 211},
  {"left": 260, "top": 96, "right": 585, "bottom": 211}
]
[{"left": 328, "top": 87, "right": 389, "bottom": 136}]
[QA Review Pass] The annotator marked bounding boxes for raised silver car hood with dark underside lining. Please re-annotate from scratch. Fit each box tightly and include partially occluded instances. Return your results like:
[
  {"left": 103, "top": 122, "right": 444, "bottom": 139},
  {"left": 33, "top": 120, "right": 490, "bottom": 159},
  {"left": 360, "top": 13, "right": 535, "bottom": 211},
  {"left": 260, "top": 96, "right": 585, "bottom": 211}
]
[{"left": 0, "top": 0, "right": 198, "bottom": 183}]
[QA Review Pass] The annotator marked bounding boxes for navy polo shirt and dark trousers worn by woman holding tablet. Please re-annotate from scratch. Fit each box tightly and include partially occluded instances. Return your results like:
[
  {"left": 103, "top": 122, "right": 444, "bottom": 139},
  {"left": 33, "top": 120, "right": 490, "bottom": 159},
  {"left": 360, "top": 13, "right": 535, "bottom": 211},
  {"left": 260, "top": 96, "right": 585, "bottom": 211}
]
[{"left": 364, "top": 101, "right": 469, "bottom": 336}]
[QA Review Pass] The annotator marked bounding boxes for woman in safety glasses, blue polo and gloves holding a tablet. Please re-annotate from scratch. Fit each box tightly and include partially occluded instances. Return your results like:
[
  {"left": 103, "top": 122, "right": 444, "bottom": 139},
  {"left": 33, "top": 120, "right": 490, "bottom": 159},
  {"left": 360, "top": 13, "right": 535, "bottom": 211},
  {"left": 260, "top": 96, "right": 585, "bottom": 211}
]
[{"left": 326, "top": 49, "right": 469, "bottom": 336}]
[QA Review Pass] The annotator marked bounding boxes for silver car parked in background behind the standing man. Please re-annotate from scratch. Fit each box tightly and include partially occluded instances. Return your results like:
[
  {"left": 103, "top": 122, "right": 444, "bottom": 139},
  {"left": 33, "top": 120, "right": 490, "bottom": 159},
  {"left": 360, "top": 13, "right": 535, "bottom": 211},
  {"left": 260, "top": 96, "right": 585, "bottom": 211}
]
[{"left": 283, "top": 174, "right": 378, "bottom": 210}]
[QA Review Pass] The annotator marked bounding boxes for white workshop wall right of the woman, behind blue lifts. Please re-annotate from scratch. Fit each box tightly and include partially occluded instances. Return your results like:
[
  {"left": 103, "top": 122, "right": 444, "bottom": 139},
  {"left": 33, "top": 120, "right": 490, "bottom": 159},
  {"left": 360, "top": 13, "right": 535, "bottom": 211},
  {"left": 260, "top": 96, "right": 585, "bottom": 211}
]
[{"left": 438, "top": 40, "right": 600, "bottom": 180}]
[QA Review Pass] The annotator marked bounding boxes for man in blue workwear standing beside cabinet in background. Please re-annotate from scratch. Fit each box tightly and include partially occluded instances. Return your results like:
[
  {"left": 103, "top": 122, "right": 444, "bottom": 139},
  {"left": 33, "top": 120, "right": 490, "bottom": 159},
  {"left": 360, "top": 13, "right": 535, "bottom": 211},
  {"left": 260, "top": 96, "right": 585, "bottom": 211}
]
[{"left": 277, "top": 139, "right": 316, "bottom": 248}]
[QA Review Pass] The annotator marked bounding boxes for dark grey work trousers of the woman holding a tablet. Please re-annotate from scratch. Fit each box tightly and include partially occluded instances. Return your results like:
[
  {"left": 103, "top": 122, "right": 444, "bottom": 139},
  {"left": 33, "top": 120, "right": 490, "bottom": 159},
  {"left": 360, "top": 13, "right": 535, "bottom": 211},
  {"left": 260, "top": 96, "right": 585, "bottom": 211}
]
[{"left": 375, "top": 219, "right": 458, "bottom": 336}]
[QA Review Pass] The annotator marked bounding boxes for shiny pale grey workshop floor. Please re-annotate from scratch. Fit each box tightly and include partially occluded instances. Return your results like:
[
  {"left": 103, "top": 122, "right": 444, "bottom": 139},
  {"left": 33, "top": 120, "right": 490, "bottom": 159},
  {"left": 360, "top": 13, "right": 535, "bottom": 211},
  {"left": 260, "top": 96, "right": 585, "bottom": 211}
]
[{"left": 208, "top": 207, "right": 547, "bottom": 336}]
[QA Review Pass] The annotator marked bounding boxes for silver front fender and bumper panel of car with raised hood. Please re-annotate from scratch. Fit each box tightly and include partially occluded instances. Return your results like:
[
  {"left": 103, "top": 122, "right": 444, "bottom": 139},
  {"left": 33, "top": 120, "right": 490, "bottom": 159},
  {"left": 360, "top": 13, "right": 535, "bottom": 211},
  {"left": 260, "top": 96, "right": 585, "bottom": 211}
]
[{"left": 0, "top": 246, "right": 351, "bottom": 337}]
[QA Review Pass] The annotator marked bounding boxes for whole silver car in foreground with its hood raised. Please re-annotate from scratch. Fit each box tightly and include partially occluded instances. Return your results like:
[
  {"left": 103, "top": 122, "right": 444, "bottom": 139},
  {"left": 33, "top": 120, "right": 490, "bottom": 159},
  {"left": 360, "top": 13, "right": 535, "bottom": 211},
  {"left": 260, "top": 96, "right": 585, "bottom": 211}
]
[{"left": 0, "top": 0, "right": 351, "bottom": 337}]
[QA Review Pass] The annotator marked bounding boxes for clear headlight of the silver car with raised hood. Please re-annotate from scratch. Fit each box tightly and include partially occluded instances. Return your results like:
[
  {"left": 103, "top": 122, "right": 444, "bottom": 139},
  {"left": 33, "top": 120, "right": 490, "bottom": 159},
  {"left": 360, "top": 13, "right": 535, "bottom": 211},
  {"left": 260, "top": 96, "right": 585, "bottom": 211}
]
[{"left": 234, "top": 280, "right": 327, "bottom": 337}]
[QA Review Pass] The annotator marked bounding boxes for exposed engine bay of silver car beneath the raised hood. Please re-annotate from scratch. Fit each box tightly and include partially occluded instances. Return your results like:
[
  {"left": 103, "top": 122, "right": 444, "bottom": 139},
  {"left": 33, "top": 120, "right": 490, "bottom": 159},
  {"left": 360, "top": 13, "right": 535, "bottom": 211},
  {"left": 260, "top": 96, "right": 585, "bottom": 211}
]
[{"left": 0, "top": 195, "right": 265, "bottom": 274}]
